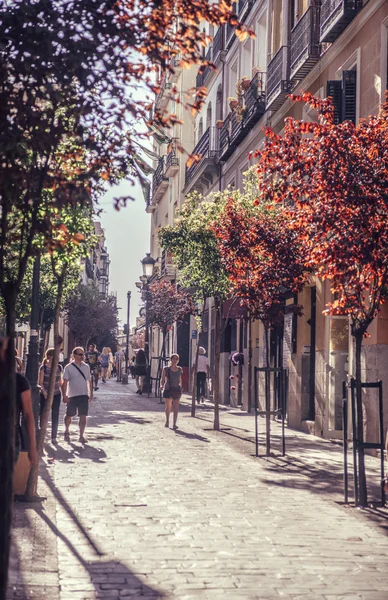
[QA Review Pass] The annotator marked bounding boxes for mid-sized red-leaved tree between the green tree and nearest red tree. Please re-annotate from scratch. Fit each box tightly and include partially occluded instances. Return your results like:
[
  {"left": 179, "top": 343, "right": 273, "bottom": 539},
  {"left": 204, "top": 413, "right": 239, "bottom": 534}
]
[{"left": 213, "top": 172, "right": 307, "bottom": 454}]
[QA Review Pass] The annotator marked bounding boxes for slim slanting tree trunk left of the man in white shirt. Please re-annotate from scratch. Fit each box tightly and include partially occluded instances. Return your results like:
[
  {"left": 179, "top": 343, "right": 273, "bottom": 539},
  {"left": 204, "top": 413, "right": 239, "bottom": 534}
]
[{"left": 25, "top": 273, "right": 65, "bottom": 502}]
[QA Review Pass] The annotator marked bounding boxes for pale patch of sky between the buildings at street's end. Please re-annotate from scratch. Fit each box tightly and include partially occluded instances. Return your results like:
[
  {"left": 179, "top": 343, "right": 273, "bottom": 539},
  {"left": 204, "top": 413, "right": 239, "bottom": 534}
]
[{"left": 98, "top": 182, "right": 151, "bottom": 327}]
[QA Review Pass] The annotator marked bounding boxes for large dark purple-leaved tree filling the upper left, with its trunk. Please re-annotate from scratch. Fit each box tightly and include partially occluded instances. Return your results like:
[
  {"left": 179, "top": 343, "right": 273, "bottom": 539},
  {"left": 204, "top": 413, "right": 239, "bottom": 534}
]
[{"left": 0, "top": 0, "right": 247, "bottom": 593}]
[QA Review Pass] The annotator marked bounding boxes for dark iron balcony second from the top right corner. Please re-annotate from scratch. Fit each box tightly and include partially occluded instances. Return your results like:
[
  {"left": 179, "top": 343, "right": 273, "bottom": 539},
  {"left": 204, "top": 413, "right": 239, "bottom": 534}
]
[{"left": 290, "top": 6, "right": 321, "bottom": 82}]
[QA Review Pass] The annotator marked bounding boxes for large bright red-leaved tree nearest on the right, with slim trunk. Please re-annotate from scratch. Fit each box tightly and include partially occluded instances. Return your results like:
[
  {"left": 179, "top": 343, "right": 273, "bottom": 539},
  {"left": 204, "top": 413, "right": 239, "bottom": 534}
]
[{"left": 256, "top": 93, "right": 388, "bottom": 506}]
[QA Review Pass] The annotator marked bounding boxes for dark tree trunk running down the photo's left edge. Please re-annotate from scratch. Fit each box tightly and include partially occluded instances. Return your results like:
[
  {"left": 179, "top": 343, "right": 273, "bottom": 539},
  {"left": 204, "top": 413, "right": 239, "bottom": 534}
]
[{"left": 0, "top": 290, "right": 16, "bottom": 598}]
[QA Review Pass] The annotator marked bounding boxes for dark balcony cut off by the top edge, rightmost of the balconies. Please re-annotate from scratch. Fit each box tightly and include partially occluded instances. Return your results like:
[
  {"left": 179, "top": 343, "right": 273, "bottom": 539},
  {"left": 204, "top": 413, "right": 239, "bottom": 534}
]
[{"left": 320, "top": 0, "right": 362, "bottom": 42}]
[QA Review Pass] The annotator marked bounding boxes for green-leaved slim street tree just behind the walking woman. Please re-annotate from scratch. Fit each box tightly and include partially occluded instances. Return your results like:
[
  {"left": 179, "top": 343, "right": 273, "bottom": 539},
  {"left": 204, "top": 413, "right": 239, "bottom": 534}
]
[{"left": 159, "top": 193, "right": 230, "bottom": 430}]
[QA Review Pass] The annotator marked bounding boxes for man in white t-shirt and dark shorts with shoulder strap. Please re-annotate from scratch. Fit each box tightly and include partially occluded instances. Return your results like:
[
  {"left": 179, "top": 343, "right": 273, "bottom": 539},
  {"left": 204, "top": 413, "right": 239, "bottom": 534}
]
[{"left": 62, "top": 346, "right": 93, "bottom": 444}]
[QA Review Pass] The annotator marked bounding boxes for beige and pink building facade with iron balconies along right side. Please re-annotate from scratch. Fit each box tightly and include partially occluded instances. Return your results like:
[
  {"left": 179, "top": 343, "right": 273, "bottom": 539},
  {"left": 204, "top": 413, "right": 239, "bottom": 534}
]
[{"left": 147, "top": 0, "right": 388, "bottom": 441}]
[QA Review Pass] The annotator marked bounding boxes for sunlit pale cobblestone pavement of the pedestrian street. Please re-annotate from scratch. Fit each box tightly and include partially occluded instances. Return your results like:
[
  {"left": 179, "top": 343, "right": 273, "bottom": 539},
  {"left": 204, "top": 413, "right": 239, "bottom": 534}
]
[{"left": 8, "top": 381, "right": 388, "bottom": 600}]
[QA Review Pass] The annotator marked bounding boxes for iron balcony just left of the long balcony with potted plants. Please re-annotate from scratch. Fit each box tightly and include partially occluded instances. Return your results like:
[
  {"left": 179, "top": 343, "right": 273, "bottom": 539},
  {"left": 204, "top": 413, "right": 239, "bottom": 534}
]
[{"left": 183, "top": 127, "right": 218, "bottom": 194}]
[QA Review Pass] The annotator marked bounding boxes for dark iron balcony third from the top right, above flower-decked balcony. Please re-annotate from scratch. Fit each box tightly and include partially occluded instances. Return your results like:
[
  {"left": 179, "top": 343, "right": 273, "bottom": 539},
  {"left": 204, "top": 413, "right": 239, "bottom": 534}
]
[{"left": 267, "top": 46, "right": 290, "bottom": 110}]
